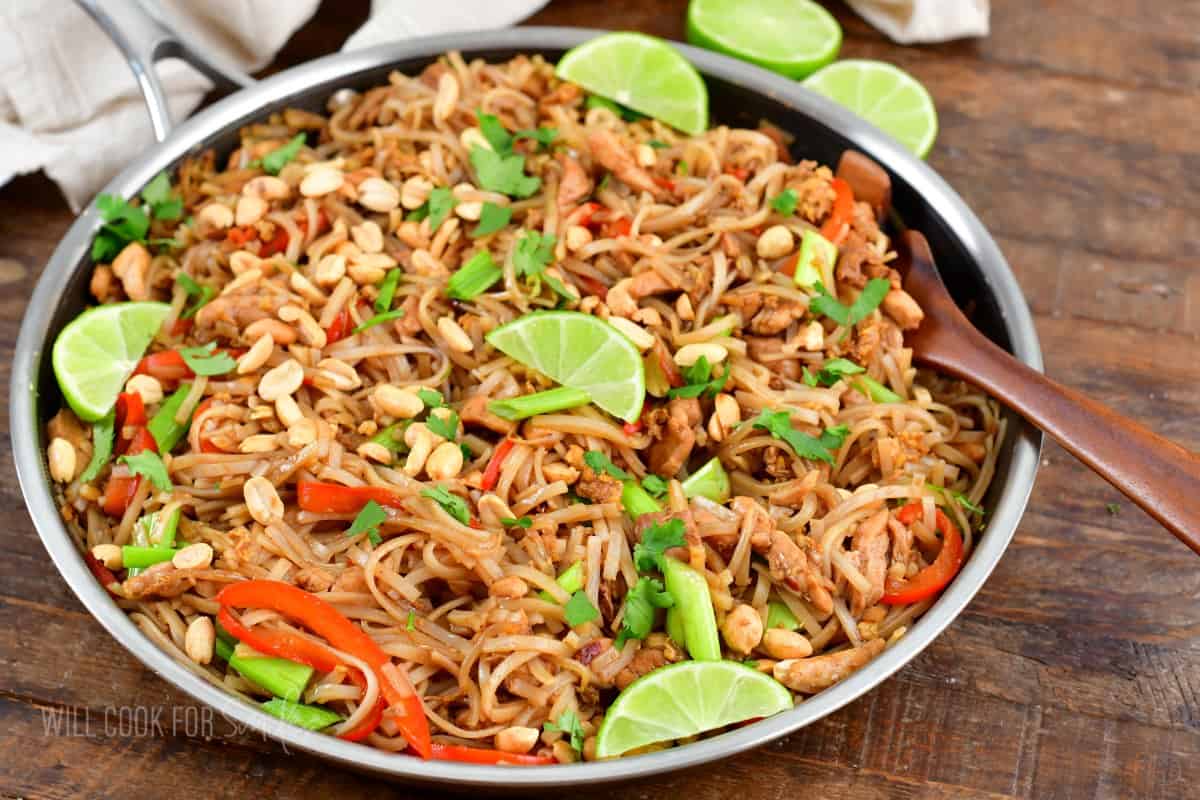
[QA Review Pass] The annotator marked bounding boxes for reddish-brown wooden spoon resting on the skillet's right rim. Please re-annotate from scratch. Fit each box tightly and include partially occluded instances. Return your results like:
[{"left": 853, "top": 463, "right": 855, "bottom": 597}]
[{"left": 896, "top": 230, "right": 1200, "bottom": 554}]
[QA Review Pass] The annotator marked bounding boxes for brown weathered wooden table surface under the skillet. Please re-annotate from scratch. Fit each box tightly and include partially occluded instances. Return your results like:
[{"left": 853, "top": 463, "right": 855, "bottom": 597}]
[{"left": 0, "top": 0, "right": 1200, "bottom": 800}]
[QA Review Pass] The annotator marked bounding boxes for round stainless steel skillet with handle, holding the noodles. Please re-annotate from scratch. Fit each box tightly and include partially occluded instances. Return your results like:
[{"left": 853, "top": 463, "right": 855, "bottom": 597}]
[{"left": 10, "top": 0, "right": 1042, "bottom": 790}]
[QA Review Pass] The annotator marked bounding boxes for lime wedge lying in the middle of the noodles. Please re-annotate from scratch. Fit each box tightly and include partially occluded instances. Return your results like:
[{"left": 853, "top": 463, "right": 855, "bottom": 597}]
[{"left": 487, "top": 311, "right": 646, "bottom": 422}]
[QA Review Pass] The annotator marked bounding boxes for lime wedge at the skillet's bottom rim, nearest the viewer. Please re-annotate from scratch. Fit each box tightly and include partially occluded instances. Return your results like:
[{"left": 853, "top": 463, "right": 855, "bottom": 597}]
[{"left": 596, "top": 661, "right": 792, "bottom": 758}]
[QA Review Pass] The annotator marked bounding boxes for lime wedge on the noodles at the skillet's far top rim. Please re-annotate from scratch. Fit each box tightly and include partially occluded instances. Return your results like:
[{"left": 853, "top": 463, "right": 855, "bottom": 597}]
[{"left": 554, "top": 34, "right": 708, "bottom": 136}]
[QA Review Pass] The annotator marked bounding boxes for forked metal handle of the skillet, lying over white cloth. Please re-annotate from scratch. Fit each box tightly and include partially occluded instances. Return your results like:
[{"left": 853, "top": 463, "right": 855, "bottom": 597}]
[{"left": 76, "top": 0, "right": 254, "bottom": 142}]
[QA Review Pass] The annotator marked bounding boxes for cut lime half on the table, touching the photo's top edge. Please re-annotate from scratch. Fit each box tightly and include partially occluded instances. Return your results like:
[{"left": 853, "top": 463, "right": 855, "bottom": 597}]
[{"left": 688, "top": 0, "right": 841, "bottom": 78}]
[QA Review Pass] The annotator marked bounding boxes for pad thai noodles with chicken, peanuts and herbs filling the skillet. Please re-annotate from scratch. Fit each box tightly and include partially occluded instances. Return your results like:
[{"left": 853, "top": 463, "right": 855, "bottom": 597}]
[{"left": 47, "top": 53, "right": 1004, "bottom": 764}]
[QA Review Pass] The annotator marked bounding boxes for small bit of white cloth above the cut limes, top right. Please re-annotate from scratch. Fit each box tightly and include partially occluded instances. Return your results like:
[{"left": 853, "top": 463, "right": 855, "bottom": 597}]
[{"left": 846, "top": 0, "right": 989, "bottom": 44}]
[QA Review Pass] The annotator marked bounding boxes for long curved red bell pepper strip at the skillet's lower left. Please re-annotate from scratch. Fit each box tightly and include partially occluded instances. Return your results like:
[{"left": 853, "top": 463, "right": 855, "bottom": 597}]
[{"left": 217, "top": 581, "right": 432, "bottom": 758}]
